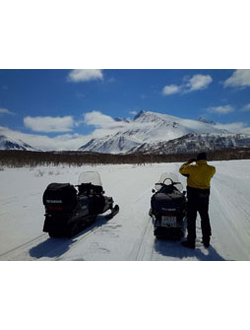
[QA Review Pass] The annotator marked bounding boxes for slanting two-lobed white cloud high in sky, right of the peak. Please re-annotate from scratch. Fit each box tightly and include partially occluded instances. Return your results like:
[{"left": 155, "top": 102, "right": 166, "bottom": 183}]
[{"left": 162, "top": 74, "right": 213, "bottom": 96}]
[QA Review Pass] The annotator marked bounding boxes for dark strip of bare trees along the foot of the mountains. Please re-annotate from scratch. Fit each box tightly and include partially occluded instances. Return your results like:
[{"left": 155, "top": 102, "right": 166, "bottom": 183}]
[{"left": 0, "top": 148, "right": 250, "bottom": 167}]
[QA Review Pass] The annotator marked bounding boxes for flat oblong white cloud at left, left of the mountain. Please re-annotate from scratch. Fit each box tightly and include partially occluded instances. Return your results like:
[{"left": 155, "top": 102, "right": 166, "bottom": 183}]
[{"left": 23, "top": 116, "right": 74, "bottom": 133}]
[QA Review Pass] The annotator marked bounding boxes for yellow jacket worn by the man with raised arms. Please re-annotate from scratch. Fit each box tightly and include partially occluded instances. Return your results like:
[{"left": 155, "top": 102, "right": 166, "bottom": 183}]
[{"left": 180, "top": 160, "right": 216, "bottom": 189}]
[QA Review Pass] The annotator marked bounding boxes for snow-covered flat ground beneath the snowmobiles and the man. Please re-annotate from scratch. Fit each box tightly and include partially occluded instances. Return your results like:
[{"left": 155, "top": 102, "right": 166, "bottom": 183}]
[{"left": 0, "top": 161, "right": 250, "bottom": 261}]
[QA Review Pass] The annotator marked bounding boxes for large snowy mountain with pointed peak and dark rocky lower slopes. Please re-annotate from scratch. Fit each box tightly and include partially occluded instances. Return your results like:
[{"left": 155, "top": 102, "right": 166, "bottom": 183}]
[{"left": 79, "top": 111, "right": 250, "bottom": 154}]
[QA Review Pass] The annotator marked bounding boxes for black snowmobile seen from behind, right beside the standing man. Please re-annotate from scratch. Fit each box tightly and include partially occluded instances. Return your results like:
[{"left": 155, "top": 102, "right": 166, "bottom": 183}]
[{"left": 149, "top": 173, "right": 187, "bottom": 240}]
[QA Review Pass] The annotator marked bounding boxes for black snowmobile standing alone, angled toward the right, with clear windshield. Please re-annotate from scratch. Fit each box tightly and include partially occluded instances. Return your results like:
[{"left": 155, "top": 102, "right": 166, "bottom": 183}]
[{"left": 43, "top": 171, "right": 119, "bottom": 238}]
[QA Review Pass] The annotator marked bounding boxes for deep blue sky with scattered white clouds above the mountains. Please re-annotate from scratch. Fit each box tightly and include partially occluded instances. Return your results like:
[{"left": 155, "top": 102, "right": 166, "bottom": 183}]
[{"left": 0, "top": 69, "right": 250, "bottom": 151}]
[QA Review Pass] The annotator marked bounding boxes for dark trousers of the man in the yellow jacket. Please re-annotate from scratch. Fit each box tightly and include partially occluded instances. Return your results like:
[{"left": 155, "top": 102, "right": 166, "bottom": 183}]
[{"left": 187, "top": 187, "right": 212, "bottom": 243}]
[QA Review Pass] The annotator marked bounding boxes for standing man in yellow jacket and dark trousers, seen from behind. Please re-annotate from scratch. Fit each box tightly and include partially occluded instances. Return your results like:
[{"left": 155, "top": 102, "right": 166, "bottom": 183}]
[{"left": 180, "top": 153, "right": 216, "bottom": 249}]
